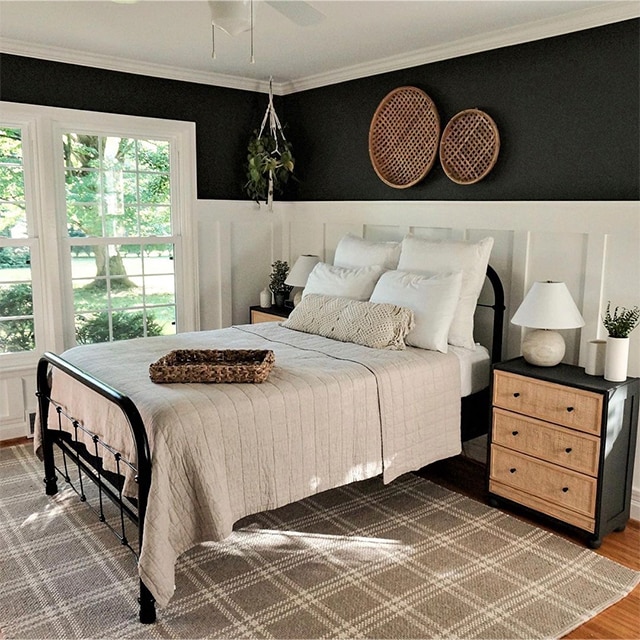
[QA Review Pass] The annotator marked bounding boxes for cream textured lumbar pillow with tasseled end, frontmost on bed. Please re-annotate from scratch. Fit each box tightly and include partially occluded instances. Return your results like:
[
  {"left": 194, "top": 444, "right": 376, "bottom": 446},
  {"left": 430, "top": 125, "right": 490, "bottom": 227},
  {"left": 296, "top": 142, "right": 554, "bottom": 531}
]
[{"left": 282, "top": 294, "right": 413, "bottom": 351}]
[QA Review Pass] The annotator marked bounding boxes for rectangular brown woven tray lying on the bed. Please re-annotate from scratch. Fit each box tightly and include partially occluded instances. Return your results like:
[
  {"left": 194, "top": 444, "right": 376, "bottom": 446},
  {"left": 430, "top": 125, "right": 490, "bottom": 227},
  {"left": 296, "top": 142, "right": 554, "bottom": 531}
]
[{"left": 149, "top": 349, "right": 276, "bottom": 383}]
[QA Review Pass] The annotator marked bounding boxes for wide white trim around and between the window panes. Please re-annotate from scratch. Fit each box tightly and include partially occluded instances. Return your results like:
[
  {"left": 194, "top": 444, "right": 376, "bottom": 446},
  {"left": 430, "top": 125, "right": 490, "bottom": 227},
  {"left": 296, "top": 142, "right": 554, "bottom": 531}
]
[{"left": 0, "top": 101, "right": 200, "bottom": 369}]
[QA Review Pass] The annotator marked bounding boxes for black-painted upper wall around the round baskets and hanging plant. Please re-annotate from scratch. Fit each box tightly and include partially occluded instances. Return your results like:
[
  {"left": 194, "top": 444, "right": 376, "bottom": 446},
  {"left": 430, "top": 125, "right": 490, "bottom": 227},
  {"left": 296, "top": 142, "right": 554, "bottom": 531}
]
[{"left": 0, "top": 20, "right": 640, "bottom": 200}]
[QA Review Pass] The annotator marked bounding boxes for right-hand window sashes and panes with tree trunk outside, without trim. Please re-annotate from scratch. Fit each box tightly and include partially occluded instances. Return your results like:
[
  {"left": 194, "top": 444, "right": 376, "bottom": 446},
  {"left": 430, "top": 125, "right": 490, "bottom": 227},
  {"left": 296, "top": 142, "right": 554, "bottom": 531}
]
[{"left": 62, "top": 133, "right": 176, "bottom": 344}]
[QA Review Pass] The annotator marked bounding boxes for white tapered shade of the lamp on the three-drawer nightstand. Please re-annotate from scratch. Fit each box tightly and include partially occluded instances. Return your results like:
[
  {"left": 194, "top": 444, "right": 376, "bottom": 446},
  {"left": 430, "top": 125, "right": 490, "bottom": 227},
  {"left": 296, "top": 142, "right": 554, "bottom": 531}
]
[{"left": 511, "top": 282, "right": 584, "bottom": 329}]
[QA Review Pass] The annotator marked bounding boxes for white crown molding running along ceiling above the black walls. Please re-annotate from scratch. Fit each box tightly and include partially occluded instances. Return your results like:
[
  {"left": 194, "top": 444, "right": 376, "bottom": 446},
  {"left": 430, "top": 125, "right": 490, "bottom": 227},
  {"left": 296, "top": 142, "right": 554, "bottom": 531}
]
[{"left": 0, "top": 0, "right": 640, "bottom": 95}]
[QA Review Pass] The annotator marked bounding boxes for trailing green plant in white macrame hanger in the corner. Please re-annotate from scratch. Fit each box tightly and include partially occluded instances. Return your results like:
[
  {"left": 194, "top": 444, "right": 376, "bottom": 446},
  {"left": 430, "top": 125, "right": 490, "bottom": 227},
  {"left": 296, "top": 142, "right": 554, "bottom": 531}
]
[{"left": 244, "top": 78, "right": 294, "bottom": 209}]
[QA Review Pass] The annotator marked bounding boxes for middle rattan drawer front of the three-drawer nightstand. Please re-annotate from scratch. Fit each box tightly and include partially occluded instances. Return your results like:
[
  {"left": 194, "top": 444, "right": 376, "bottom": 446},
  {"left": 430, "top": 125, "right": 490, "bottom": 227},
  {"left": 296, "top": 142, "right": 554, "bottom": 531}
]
[{"left": 491, "top": 409, "right": 600, "bottom": 477}]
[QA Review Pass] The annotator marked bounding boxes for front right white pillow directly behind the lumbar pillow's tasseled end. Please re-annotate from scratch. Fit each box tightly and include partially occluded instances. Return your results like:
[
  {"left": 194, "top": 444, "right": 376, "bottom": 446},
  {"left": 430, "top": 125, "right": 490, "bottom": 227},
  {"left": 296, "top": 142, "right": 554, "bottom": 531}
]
[{"left": 371, "top": 271, "right": 462, "bottom": 353}]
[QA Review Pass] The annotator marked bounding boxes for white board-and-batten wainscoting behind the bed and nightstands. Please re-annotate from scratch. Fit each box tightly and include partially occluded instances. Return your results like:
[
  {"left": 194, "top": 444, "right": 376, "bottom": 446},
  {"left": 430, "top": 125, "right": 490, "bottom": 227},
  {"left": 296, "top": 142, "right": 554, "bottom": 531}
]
[{"left": 197, "top": 201, "right": 640, "bottom": 520}]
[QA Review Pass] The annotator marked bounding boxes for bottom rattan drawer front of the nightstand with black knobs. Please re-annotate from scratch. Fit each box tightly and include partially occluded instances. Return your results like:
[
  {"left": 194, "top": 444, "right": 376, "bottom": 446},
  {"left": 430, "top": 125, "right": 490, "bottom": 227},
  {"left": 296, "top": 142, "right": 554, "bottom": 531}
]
[{"left": 491, "top": 445, "right": 597, "bottom": 517}]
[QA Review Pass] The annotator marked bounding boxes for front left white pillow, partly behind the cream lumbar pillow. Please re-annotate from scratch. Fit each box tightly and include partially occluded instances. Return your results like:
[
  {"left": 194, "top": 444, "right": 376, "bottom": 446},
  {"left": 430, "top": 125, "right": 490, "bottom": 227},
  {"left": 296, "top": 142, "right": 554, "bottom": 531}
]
[{"left": 302, "top": 262, "right": 383, "bottom": 300}]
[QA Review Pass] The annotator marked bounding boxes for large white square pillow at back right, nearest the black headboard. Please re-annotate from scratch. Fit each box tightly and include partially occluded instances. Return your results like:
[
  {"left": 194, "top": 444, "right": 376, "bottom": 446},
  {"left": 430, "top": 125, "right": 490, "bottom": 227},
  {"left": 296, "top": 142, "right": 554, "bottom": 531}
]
[{"left": 398, "top": 236, "right": 493, "bottom": 349}]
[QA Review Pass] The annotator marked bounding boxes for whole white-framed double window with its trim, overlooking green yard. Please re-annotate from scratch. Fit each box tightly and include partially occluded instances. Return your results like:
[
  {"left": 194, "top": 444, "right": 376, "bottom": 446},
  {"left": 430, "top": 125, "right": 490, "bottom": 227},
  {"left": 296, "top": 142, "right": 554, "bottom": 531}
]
[{"left": 0, "top": 103, "right": 199, "bottom": 366}]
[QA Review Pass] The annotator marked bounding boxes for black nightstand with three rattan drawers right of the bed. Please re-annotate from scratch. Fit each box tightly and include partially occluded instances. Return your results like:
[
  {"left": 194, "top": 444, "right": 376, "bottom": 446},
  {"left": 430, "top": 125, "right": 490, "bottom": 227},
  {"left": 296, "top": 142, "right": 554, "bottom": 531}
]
[{"left": 488, "top": 358, "right": 640, "bottom": 549}]
